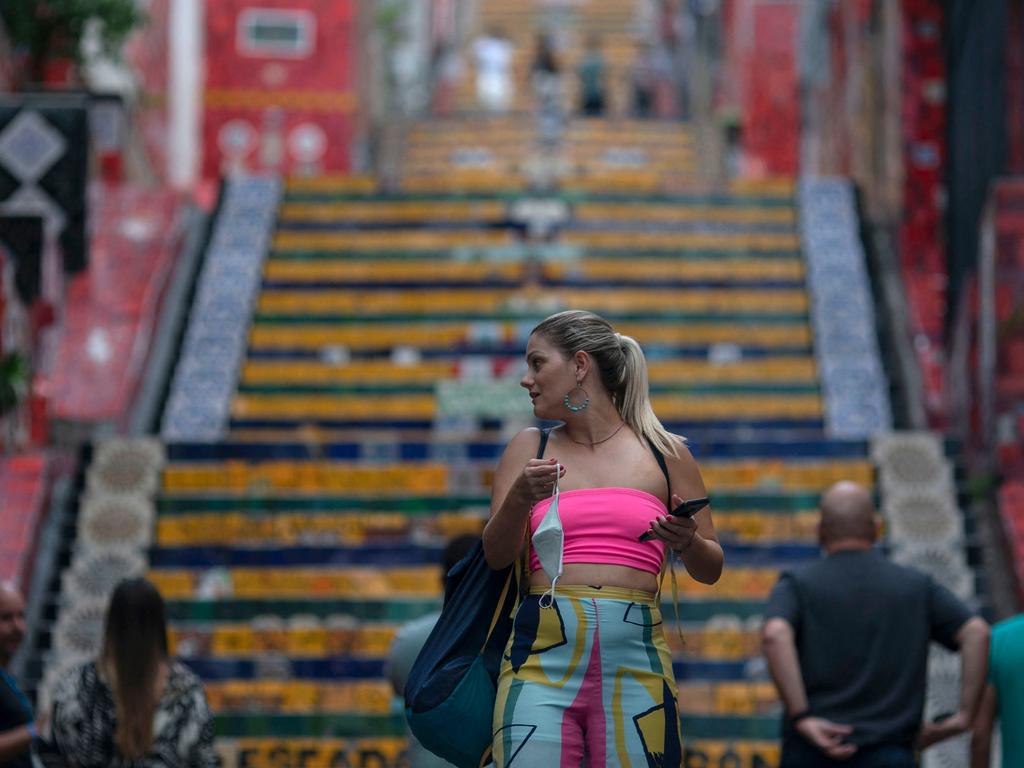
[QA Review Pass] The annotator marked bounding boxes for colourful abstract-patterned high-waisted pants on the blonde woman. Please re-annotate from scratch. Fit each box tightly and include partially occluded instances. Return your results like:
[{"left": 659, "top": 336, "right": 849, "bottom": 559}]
[{"left": 493, "top": 587, "right": 682, "bottom": 768}]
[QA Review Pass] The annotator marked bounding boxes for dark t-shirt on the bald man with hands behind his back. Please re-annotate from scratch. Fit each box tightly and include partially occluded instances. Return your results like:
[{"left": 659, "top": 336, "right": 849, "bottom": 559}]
[{"left": 767, "top": 550, "right": 972, "bottom": 746}]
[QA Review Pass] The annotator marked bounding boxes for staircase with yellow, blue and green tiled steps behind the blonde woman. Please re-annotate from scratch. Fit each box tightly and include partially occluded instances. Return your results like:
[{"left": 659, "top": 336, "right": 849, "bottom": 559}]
[{"left": 144, "top": 125, "right": 897, "bottom": 766}]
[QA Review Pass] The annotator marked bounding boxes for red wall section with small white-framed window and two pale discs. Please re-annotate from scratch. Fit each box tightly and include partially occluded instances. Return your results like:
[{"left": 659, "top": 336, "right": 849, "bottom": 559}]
[{"left": 203, "top": 0, "right": 357, "bottom": 177}]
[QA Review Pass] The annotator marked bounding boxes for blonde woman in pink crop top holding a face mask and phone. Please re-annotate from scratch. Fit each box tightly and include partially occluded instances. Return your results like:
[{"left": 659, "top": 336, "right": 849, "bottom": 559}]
[{"left": 483, "top": 310, "right": 723, "bottom": 768}]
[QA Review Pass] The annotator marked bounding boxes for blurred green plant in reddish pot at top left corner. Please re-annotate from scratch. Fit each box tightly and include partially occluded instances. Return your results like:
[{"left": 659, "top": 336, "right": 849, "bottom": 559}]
[{"left": 0, "top": 0, "right": 142, "bottom": 86}]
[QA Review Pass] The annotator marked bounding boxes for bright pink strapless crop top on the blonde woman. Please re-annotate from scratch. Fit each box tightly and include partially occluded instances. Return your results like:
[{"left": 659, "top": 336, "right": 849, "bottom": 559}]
[{"left": 529, "top": 488, "right": 668, "bottom": 575}]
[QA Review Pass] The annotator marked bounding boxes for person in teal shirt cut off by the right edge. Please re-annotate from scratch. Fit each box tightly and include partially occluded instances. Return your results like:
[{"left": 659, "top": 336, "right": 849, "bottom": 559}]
[{"left": 971, "top": 613, "right": 1024, "bottom": 768}]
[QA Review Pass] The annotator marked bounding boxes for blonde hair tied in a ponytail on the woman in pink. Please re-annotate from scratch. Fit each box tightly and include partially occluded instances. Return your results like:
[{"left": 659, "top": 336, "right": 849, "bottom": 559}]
[{"left": 532, "top": 309, "right": 679, "bottom": 456}]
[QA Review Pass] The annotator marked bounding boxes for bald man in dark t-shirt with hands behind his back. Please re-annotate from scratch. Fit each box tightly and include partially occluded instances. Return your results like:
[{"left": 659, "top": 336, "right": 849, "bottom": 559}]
[{"left": 762, "top": 482, "right": 989, "bottom": 768}]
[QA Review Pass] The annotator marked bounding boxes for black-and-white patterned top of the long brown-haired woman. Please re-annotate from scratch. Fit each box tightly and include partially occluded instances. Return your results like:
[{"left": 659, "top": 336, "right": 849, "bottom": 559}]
[{"left": 51, "top": 662, "right": 217, "bottom": 768}]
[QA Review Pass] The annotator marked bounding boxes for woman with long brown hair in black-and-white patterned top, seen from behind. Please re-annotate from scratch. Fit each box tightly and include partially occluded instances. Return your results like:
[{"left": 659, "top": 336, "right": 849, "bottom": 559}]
[{"left": 53, "top": 579, "right": 217, "bottom": 768}]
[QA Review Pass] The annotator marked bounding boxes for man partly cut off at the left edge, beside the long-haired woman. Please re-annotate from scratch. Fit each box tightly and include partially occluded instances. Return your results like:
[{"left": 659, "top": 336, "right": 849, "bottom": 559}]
[{"left": 0, "top": 582, "right": 37, "bottom": 768}]
